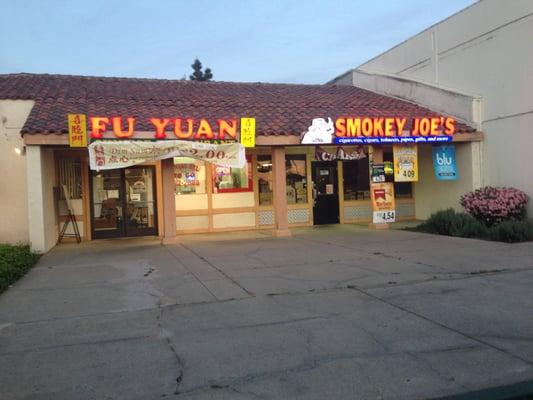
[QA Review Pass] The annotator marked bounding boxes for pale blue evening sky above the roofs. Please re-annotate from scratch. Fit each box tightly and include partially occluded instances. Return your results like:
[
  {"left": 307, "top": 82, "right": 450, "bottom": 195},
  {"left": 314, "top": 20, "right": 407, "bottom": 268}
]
[{"left": 0, "top": 0, "right": 475, "bottom": 84}]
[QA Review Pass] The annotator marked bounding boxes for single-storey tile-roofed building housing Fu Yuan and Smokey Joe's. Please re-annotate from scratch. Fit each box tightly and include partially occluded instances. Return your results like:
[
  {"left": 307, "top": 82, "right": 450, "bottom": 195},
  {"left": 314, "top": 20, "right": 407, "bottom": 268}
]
[{"left": 0, "top": 74, "right": 483, "bottom": 251}]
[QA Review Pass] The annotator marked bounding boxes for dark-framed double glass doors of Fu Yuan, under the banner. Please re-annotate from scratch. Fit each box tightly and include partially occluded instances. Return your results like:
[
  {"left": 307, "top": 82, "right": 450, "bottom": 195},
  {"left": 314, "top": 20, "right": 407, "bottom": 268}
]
[{"left": 91, "top": 166, "right": 157, "bottom": 239}]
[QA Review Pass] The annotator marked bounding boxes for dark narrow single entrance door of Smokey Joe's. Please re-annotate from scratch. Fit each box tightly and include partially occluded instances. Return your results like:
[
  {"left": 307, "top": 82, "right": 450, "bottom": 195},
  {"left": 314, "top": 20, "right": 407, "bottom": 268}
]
[{"left": 312, "top": 161, "right": 339, "bottom": 225}]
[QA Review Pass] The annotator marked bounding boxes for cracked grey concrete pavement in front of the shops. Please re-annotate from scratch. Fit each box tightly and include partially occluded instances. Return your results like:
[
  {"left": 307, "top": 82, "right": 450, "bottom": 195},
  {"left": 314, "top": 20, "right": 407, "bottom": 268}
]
[{"left": 0, "top": 225, "right": 533, "bottom": 399}]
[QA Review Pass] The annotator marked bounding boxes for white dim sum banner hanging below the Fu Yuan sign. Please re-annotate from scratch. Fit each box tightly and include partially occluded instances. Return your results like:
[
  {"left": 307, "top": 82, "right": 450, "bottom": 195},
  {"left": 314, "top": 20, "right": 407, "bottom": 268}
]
[{"left": 89, "top": 140, "right": 246, "bottom": 170}]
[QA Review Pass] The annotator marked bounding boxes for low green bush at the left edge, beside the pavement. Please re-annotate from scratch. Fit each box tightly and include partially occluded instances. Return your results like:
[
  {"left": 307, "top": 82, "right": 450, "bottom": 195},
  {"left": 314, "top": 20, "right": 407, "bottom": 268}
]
[{"left": 0, "top": 244, "right": 39, "bottom": 293}]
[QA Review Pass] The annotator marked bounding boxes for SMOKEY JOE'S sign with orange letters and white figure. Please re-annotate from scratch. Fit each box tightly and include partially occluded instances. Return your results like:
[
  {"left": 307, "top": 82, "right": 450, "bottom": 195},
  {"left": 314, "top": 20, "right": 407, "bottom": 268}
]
[{"left": 301, "top": 117, "right": 456, "bottom": 144}]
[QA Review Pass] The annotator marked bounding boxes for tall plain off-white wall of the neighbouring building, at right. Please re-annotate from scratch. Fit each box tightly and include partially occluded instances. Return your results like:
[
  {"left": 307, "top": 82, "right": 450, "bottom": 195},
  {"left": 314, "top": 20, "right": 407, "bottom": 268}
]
[{"left": 334, "top": 0, "right": 533, "bottom": 215}]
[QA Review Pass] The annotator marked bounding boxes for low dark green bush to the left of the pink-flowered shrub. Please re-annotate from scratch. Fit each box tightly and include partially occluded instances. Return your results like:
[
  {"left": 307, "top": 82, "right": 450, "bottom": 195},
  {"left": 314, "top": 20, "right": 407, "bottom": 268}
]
[{"left": 416, "top": 208, "right": 488, "bottom": 238}]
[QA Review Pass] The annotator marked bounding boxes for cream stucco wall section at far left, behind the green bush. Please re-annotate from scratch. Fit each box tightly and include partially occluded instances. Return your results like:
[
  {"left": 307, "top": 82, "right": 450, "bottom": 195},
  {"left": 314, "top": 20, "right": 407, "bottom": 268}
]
[{"left": 0, "top": 100, "right": 34, "bottom": 243}]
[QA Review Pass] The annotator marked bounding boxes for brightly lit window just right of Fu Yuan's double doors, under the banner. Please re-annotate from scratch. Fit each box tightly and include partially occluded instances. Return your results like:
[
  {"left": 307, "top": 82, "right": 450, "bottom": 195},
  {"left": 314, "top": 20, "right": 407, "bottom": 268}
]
[{"left": 174, "top": 157, "right": 206, "bottom": 194}]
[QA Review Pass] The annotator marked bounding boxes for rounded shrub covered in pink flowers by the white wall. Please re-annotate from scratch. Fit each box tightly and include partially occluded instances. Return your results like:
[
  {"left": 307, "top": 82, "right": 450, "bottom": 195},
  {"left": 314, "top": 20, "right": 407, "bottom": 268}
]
[{"left": 460, "top": 186, "right": 528, "bottom": 226}]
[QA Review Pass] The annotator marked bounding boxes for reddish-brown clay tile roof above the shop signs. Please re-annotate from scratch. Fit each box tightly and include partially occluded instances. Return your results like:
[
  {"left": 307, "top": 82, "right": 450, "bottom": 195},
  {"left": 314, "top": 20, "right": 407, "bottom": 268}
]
[{"left": 0, "top": 73, "right": 475, "bottom": 135}]
